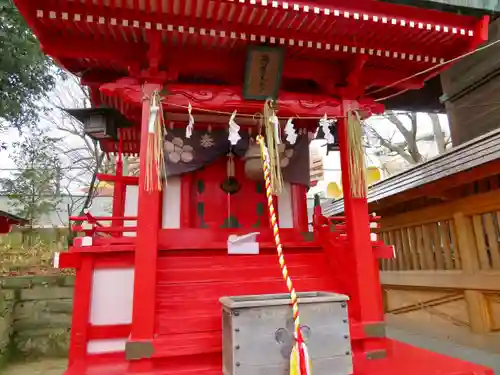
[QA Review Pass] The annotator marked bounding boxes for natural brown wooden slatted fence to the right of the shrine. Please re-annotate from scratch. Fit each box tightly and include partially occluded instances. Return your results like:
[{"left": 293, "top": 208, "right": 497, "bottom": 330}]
[{"left": 379, "top": 190, "right": 500, "bottom": 333}]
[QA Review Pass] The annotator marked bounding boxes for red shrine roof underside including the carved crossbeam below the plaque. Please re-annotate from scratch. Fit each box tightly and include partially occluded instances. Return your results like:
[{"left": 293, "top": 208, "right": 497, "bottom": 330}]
[{"left": 15, "top": 0, "right": 488, "bottom": 154}]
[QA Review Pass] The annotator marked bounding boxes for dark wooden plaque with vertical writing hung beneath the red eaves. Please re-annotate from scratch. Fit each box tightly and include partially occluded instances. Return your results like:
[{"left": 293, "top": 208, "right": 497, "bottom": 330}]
[{"left": 243, "top": 46, "right": 283, "bottom": 100}]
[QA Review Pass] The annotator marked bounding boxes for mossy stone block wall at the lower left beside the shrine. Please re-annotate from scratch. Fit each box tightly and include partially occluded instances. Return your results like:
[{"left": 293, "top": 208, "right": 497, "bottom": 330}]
[{"left": 0, "top": 275, "right": 74, "bottom": 362}]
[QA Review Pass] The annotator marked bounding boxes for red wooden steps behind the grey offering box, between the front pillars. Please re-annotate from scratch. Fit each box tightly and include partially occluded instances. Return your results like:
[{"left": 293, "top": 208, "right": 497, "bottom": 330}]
[{"left": 150, "top": 248, "right": 333, "bottom": 358}]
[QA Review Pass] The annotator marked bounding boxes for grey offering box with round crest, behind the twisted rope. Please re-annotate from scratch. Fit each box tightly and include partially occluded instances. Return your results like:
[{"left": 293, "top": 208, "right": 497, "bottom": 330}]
[{"left": 220, "top": 292, "right": 353, "bottom": 375}]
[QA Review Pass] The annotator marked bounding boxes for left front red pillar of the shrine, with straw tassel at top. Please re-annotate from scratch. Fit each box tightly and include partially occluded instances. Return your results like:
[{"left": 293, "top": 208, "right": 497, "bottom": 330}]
[{"left": 129, "top": 84, "right": 162, "bottom": 346}]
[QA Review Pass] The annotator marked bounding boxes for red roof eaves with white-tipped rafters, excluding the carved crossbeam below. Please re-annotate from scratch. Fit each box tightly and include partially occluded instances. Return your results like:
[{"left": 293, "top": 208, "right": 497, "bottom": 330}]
[{"left": 15, "top": 0, "right": 488, "bottom": 100}]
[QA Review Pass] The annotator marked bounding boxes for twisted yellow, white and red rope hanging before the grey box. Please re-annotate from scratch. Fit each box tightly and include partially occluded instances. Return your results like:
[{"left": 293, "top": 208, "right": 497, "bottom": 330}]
[{"left": 257, "top": 135, "right": 312, "bottom": 375}]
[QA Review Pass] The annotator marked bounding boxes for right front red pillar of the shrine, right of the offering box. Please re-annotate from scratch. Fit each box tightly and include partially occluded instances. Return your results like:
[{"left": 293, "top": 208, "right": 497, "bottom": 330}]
[{"left": 338, "top": 102, "right": 384, "bottom": 352}]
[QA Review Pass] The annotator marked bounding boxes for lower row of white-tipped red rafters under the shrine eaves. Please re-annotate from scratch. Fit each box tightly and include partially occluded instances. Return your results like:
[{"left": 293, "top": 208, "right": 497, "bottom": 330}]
[{"left": 36, "top": 1, "right": 468, "bottom": 65}]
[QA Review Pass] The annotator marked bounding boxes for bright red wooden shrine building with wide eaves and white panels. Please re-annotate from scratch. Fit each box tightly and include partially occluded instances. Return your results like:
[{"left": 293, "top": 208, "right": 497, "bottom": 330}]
[{"left": 15, "top": 0, "right": 491, "bottom": 375}]
